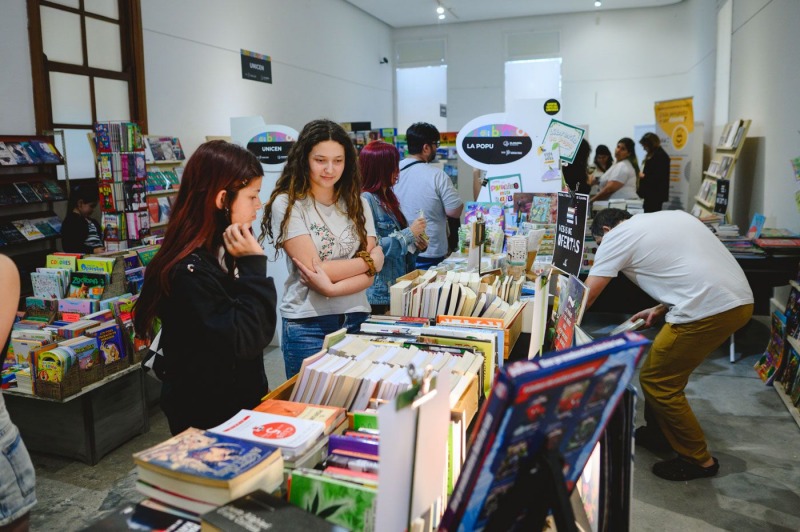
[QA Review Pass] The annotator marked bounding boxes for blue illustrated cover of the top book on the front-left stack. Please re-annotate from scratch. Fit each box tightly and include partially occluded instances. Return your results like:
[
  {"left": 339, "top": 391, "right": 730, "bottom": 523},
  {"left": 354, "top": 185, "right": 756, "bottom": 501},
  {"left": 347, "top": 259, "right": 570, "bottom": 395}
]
[{"left": 133, "top": 428, "right": 280, "bottom": 484}]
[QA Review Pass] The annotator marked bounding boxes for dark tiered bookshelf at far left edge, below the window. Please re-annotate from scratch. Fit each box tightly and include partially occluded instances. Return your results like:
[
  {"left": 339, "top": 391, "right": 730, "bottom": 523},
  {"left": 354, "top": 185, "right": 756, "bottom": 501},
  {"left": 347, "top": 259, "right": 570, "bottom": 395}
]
[{"left": 0, "top": 135, "right": 69, "bottom": 296}]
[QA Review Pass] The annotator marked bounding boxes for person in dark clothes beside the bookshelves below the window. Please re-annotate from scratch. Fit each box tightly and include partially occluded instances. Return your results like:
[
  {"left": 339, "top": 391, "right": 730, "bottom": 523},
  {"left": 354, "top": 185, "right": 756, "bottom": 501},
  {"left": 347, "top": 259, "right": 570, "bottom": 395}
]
[{"left": 61, "top": 183, "right": 105, "bottom": 253}]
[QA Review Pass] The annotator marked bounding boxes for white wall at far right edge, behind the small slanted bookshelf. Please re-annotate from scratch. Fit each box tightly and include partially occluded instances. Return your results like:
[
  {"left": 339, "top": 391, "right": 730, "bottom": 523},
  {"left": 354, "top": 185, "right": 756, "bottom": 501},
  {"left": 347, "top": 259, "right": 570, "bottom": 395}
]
[{"left": 730, "top": 0, "right": 800, "bottom": 231}]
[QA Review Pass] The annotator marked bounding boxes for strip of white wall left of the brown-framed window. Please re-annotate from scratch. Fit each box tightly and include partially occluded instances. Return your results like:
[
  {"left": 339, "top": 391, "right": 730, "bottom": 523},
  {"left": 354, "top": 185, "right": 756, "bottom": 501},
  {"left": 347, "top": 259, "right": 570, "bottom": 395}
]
[{"left": 0, "top": 0, "right": 37, "bottom": 135}]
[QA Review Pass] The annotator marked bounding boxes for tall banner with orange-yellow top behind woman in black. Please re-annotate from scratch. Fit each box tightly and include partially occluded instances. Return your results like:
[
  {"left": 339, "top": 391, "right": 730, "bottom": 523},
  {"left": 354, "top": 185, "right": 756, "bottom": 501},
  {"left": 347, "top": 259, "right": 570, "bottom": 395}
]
[{"left": 655, "top": 97, "right": 694, "bottom": 209}]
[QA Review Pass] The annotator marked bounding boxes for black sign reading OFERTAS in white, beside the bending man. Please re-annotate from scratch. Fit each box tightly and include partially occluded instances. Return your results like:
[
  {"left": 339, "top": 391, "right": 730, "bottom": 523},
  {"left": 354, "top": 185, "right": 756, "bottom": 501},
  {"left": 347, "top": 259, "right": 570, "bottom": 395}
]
[{"left": 553, "top": 192, "right": 589, "bottom": 276}]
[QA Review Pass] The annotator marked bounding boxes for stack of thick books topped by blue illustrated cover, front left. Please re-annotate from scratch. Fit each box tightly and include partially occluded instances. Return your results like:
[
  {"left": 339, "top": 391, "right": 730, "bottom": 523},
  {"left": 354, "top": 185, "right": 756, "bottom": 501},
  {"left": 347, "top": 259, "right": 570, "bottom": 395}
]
[{"left": 133, "top": 428, "right": 283, "bottom": 515}]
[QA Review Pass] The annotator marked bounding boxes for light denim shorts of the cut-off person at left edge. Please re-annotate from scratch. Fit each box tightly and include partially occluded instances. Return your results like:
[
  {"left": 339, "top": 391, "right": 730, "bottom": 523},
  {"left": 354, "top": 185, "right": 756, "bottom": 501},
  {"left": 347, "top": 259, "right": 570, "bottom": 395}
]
[{"left": 0, "top": 396, "right": 36, "bottom": 527}]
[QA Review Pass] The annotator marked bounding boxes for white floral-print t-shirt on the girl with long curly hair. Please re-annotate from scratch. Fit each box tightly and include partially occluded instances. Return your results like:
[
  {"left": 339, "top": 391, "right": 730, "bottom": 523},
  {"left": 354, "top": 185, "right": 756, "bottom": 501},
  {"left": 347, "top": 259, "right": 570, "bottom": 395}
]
[{"left": 272, "top": 194, "right": 376, "bottom": 319}]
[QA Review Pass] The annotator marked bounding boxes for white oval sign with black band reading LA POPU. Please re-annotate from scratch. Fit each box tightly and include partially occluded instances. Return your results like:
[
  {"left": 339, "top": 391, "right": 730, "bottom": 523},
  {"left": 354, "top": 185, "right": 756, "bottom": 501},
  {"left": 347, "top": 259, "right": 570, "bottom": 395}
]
[{"left": 461, "top": 124, "right": 533, "bottom": 165}]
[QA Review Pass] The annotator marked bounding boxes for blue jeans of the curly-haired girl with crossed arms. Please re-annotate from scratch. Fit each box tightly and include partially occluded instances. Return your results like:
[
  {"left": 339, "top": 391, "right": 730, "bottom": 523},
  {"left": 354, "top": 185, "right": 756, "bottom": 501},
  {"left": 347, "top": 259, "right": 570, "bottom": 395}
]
[{"left": 281, "top": 312, "right": 369, "bottom": 379}]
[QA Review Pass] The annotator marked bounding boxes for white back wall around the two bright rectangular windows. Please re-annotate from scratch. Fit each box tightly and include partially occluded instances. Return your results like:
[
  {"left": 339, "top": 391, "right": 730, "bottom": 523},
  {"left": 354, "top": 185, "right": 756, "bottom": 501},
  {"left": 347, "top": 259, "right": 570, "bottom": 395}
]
[{"left": 394, "top": 0, "right": 716, "bottom": 206}]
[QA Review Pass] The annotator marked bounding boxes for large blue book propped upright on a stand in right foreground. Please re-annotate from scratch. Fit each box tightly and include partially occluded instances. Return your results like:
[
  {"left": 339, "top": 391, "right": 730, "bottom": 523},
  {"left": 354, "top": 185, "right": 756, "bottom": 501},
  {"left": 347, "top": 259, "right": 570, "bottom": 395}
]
[{"left": 440, "top": 333, "right": 650, "bottom": 530}]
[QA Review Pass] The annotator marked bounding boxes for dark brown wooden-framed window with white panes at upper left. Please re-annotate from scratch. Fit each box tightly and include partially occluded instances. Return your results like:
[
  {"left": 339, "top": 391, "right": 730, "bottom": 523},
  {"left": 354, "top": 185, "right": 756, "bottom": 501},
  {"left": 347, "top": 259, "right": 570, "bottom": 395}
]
[{"left": 28, "top": 0, "right": 147, "bottom": 179}]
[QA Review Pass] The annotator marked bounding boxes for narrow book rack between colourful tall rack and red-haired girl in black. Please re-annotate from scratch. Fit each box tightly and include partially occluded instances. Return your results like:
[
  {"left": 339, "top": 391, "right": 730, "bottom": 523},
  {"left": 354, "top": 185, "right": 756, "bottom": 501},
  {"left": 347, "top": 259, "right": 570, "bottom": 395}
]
[{"left": 144, "top": 135, "right": 186, "bottom": 236}]
